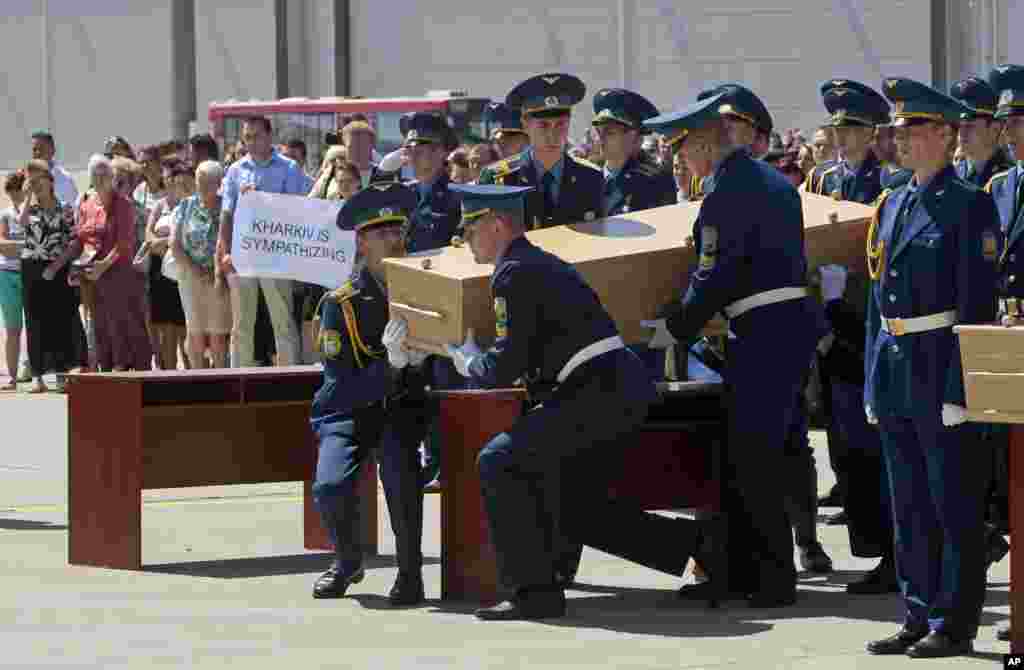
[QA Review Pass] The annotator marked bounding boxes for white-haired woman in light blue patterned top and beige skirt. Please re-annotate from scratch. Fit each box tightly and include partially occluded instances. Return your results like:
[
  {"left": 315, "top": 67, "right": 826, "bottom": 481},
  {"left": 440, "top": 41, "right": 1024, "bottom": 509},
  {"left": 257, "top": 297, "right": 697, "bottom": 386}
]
[{"left": 171, "top": 161, "right": 231, "bottom": 368}]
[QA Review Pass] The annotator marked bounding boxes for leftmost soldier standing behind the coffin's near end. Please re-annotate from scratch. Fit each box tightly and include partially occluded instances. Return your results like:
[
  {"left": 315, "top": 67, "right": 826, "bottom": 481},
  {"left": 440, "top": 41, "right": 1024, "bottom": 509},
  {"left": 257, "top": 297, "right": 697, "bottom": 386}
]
[{"left": 402, "top": 112, "right": 459, "bottom": 253}]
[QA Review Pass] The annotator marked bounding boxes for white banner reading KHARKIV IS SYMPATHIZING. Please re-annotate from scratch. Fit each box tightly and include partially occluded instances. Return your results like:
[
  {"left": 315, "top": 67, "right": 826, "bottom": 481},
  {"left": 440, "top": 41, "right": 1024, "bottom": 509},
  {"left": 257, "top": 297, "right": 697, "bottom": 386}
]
[{"left": 231, "top": 191, "right": 355, "bottom": 289}]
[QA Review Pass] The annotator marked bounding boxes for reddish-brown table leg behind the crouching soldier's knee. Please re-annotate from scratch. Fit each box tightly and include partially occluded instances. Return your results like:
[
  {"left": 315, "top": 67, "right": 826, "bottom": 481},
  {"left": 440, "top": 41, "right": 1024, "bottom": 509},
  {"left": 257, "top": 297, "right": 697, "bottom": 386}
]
[{"left": 437, "top": 389, "right": 525, "bottom": 605}]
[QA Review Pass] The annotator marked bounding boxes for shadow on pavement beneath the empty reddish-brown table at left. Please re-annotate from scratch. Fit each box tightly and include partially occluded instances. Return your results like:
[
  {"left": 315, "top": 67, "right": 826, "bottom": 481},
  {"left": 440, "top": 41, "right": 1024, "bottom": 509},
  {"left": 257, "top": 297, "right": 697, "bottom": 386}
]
[{"left": 142, "top": 552, "right": 440, "bottom": 579}]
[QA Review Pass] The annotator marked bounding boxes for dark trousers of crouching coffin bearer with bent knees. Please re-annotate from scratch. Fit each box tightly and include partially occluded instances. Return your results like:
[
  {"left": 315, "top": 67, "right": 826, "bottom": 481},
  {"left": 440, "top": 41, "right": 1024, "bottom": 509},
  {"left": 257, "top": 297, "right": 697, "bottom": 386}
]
[{"left": 477, "top": 349, "right": 694, "bottom": 589}]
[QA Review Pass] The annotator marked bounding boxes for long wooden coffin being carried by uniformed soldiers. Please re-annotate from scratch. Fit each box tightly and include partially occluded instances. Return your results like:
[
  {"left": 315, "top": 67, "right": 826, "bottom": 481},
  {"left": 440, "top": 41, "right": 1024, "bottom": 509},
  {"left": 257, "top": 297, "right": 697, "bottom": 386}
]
[{"left": 386, "top": 194, "right": 874, "bottom": 351}]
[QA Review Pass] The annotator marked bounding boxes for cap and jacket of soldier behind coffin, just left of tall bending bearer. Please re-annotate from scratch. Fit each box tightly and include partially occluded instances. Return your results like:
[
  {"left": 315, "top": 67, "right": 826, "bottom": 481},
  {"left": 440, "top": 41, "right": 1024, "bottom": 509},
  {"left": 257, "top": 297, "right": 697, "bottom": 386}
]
[{"left": 593, "top": 88, "right": 676, "bottom": 216}]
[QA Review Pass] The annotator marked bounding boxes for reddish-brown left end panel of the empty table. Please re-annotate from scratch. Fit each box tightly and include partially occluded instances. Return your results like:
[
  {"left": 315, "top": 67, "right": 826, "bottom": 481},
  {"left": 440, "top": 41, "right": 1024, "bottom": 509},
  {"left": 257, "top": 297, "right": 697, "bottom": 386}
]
[{"left": 68, "top": 379, "right": 142, "bottom": 570}]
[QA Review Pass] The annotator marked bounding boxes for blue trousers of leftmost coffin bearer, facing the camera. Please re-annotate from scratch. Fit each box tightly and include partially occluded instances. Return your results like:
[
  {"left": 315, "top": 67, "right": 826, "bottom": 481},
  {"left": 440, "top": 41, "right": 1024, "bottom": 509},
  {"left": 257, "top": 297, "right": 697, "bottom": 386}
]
[{"left": 312, "top": 404, "right": 424, "bottom": 575}]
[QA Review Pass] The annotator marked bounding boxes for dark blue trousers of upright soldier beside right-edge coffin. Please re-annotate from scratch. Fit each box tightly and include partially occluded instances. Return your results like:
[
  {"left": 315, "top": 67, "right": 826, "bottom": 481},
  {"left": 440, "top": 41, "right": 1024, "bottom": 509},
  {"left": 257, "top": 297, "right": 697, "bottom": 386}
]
[{"left": 880, "top": 413, "right": 991, "bottom": 638}]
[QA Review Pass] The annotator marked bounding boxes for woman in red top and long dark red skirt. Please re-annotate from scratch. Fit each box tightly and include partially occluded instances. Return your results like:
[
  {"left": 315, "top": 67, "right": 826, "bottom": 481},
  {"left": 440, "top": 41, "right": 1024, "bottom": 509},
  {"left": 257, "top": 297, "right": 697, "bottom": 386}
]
[{"left": 74, "top": 156, "right": 153, "bottom": 371}]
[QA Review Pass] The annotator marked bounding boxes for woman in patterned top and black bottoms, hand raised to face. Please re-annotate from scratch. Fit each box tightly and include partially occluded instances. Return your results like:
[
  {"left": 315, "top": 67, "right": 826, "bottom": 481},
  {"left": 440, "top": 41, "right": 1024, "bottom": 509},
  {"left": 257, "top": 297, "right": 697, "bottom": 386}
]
[{"left": 17, "top": 161, "right": 81, "bottom": 393}]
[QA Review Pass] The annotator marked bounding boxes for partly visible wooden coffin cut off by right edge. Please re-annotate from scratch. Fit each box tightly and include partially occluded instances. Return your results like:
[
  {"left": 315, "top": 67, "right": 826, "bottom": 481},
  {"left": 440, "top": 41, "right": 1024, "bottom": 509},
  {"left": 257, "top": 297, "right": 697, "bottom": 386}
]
[{"left": 953, "top": 326, "right": 1024, "bottom": 423}]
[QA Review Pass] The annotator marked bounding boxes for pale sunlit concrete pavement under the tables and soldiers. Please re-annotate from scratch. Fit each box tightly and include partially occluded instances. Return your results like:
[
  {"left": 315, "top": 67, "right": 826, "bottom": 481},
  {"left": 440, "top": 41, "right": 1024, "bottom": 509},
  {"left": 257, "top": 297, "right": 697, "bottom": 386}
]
[{"left": 0, "top": 393, "right": 1010, "bottom": 670}]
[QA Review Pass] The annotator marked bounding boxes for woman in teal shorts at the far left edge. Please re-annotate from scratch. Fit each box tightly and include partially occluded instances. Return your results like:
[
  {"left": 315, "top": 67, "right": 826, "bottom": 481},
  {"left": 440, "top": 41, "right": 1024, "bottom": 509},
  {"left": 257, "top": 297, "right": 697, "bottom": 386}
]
[{"left": 0, "top": 171, "right": 26, "bottom": 390}]
